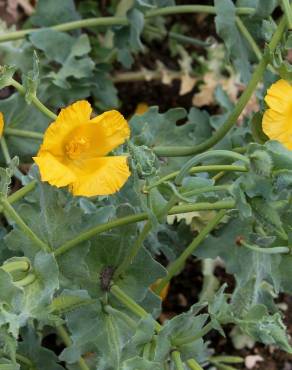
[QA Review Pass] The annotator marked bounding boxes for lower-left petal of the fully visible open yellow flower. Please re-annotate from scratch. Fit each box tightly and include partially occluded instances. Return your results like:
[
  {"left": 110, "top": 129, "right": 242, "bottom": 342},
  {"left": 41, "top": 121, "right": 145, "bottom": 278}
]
[{"left": 33, "top": 152, "right": 76, "bottom": 187}]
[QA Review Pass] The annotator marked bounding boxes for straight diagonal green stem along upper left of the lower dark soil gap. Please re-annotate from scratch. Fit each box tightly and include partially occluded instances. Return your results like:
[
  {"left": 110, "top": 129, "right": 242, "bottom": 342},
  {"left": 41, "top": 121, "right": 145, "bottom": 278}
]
[{"left": 155, "top": 210, "right": 226, "bottom": 295}]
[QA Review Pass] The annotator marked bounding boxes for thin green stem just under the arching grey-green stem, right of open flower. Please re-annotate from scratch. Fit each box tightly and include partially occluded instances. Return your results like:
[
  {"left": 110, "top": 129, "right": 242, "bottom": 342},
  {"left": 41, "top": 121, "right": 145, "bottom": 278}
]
[{"left": 145, "top": 164, "right": 248, "bottom": 191}]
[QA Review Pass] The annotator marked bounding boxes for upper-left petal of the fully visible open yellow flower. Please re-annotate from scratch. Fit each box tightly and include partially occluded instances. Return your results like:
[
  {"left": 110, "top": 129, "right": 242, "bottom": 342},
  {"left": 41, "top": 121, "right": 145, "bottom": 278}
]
[{"left": 41, "top": 100, "right": 92, "bottom": 157}]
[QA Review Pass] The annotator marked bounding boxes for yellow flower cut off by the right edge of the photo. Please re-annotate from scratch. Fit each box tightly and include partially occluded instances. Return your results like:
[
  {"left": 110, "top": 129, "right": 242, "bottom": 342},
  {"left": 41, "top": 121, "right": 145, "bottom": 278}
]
[{"left": 262, "top": 80, "right": 292, "bottom": 150}]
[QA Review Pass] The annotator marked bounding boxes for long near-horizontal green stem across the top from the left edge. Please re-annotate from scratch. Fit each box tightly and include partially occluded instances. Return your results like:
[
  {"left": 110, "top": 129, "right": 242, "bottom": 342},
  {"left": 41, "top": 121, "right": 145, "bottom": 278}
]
[{"left": 0, "top": 5, "right": 255, "bottom": 42}]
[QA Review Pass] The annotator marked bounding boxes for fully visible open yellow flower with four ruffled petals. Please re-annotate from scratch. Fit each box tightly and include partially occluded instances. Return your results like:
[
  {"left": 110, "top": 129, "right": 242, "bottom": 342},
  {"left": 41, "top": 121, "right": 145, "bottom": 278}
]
[{"left": 34, "top": 100, "right": 130, "bottom": 197}]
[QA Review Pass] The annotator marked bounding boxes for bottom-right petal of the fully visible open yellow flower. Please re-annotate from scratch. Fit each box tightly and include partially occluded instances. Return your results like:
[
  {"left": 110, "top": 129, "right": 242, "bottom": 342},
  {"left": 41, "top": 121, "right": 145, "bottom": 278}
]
[{"left": 70, "top": 156, "right": 131, "bottom": 197}]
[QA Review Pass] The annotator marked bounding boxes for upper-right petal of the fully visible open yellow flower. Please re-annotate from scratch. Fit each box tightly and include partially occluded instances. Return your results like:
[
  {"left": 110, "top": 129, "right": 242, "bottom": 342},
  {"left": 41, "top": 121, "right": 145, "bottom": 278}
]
[{"left": 87, "top": 110, "right": 130, "bottom": 156}]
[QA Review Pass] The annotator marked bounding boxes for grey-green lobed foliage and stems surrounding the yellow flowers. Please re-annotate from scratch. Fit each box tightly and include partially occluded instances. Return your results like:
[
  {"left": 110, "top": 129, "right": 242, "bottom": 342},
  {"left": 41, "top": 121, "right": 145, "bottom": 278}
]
[{"left": 0, "top": 0, "right": 292, "bottom": 370}]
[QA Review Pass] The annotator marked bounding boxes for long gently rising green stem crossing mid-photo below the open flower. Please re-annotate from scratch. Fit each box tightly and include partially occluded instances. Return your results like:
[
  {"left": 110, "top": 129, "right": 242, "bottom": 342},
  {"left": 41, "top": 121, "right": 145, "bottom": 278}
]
[{"left": 55, "top": 200, "right": 235, "bottom": 257}]
